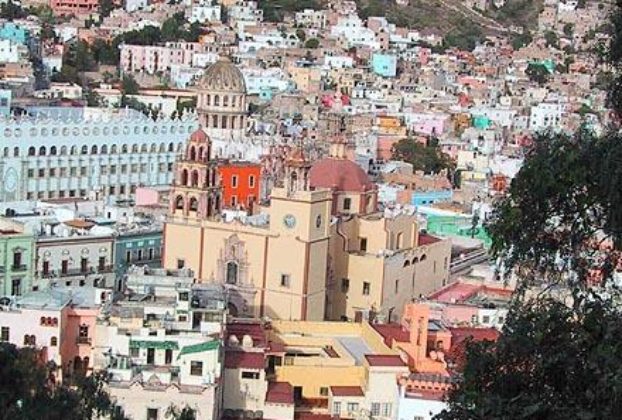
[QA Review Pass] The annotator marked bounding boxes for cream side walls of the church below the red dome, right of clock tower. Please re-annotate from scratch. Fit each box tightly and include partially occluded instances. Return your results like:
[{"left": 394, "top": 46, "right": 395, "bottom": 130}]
[{"left": 327, "top": 213, "right": 451, "bottom": 321}]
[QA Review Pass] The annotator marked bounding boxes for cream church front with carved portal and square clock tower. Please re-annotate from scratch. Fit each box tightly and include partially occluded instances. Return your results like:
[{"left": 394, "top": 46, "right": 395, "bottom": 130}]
[{"left": 164, "top": 188, "right": 331, "bottom": 320}]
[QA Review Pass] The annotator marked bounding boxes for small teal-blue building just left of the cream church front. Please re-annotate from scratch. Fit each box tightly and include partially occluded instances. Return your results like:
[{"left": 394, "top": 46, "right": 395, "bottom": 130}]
[{"left": 114, "top": 228, "right": 162, "bottom": 278}]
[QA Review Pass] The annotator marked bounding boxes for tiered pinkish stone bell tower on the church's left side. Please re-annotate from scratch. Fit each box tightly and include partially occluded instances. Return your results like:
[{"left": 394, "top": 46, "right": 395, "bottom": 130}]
[{"left": 169, "top": 128, "right": 222, "bottom": 219}]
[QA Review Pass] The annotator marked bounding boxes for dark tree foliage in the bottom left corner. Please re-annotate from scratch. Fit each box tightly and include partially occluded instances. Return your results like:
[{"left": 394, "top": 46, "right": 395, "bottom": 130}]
[{"left": 0, "top": 343, "right": 125, "bottom": 420}]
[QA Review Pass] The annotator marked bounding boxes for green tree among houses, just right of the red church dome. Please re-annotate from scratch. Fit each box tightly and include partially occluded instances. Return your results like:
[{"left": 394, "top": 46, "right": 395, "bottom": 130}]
[{"left": 393, "top": 137, "right": 455, "bottom": 174}]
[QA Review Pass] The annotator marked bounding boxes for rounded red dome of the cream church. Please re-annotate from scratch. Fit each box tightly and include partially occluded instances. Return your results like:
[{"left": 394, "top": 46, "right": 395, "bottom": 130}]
[{"left": 309, "top": 158, "right": 375, "bottom": 192}]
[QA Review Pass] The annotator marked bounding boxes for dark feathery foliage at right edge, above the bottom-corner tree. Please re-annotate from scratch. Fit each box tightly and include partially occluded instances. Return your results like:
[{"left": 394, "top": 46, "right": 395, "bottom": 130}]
[{"left": 488, "top": 130, "right": 622, "bottom": 285}]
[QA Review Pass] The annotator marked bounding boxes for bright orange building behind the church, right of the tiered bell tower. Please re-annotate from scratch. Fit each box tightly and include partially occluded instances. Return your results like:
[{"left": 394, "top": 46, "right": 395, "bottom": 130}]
[{"left": 218, "top": 162, "right": 261, "bottom": 211}]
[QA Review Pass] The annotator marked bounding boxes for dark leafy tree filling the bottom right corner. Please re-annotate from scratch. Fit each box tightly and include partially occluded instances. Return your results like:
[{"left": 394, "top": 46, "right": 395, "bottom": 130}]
[{"left": 435, "top": 294, "right": 622, "bottom": 420}]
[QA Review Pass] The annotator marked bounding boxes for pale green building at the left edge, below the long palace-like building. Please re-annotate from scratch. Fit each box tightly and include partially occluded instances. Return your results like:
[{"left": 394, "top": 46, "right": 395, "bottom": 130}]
[{"left": 0, "top": 217, "right": 35, "bottom": 296}]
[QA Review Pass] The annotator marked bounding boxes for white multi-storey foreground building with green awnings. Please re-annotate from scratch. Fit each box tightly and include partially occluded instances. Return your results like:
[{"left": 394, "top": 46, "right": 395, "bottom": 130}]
[{"left": 94, "top": 268, "right": 225, "bottom": 420}]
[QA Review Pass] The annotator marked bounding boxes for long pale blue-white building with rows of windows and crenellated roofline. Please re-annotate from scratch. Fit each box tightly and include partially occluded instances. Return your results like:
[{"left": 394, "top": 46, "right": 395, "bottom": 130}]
[{"left": 0, "top": 107, "right": 198, "bottom": 201}]
